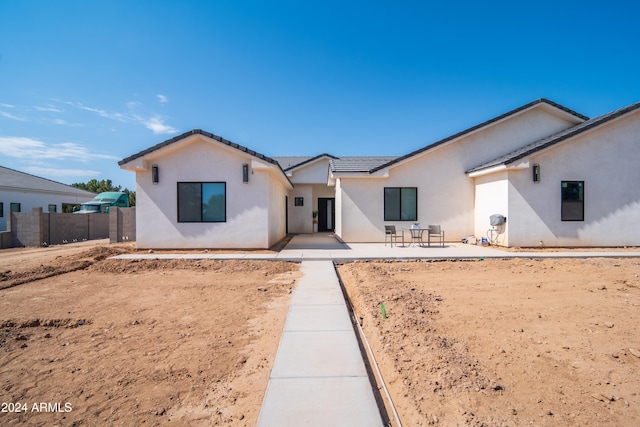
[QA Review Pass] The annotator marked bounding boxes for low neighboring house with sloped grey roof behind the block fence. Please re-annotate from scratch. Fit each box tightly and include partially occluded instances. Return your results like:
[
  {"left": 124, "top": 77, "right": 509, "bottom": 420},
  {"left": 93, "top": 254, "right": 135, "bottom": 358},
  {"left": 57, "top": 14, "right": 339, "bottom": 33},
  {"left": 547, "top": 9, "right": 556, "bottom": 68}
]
[{"left": 0, "top": 166, "right": 95, "bottom": 231}]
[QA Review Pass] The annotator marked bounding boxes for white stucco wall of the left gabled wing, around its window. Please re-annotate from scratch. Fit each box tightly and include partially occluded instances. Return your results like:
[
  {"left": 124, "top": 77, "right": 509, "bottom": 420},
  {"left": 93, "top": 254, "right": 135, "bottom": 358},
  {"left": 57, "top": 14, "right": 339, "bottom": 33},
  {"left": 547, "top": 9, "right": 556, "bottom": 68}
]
[{"left": 136, "top": 136, "right": 286, "bottom": 249}]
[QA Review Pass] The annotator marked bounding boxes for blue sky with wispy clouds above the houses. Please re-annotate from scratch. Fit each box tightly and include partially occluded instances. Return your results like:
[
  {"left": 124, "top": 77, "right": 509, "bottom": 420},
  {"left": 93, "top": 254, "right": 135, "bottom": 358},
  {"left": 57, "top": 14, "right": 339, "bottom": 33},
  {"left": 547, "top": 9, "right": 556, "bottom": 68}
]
[{"left": 0, "top": 0, "right": 640, "bottom": 189}]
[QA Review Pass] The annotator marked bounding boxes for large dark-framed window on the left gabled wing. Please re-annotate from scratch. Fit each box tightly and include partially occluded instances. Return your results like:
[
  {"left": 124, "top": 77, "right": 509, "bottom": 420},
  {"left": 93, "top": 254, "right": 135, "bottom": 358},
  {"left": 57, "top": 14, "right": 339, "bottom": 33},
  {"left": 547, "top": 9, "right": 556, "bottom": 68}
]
[{"left": 178, "top": 182, "right": 227, "bottom": 222}]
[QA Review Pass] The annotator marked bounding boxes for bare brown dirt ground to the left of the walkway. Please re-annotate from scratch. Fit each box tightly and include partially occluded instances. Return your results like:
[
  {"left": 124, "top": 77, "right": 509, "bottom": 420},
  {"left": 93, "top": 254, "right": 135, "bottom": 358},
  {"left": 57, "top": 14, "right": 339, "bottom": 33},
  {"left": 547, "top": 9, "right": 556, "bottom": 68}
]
[{"left": 0, "top": 243, "right": 300, "bottom": 426}]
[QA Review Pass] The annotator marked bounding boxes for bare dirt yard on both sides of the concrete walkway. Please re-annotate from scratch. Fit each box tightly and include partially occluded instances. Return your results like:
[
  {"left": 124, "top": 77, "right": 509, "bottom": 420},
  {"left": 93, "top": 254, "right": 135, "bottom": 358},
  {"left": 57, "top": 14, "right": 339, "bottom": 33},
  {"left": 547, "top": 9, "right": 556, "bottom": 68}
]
[{"left": 0, "top": 243, "right": 640, "bottom": 426}]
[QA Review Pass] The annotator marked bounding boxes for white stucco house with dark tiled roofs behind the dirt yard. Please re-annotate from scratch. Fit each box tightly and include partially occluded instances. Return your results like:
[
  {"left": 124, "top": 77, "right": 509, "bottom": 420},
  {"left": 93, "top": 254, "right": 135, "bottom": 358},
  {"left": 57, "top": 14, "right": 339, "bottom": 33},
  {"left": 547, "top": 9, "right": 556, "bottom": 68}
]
[{"left": 119, "top": 99, "right": 640, "bottom": 248}]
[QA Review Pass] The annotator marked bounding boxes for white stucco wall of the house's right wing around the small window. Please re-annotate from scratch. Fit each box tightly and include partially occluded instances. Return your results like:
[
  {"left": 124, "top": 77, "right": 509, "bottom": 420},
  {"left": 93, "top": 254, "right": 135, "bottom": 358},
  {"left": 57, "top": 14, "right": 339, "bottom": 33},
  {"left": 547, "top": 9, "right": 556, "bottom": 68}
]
[{"left": 507, "top": 112, "right": 640, "bottom": 247}]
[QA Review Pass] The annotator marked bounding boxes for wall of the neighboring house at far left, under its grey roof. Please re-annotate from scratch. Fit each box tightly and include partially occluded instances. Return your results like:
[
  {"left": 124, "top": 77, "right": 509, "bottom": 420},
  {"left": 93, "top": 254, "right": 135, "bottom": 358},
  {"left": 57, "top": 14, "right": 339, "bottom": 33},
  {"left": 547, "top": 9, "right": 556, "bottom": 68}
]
[{"left": 0, "top": 188, "right": 95, "bottom": 231}]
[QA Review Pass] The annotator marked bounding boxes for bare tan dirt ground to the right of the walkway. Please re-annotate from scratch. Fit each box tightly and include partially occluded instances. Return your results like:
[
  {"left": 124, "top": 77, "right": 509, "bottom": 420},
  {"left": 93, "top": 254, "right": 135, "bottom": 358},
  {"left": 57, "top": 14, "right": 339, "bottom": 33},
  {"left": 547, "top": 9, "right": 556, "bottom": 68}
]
[{"left": 339, "top": 258, "right": 640, "bottom": 426}]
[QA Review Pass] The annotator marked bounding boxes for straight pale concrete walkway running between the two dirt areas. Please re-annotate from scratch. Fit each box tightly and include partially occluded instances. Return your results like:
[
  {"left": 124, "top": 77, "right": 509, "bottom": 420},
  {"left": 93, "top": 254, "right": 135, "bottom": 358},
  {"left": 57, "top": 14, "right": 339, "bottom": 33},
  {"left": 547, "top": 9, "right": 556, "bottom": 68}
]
[{"left": 258, "top": 261, "right": 383, "bottom": 427}]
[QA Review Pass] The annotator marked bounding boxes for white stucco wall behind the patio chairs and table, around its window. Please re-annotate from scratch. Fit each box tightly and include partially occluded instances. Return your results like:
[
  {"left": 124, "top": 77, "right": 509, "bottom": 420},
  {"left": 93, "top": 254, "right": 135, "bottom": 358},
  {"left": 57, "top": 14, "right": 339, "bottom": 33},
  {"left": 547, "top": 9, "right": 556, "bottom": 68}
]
[{"left": 340, "top": 106, "right": 575, "bottom": 242}]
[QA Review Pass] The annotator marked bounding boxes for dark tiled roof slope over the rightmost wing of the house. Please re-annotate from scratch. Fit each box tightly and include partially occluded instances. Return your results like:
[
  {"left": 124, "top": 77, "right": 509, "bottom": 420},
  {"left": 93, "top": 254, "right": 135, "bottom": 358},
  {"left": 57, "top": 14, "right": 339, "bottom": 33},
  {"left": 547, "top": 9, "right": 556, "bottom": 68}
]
[{"left": 466, "top": 102, "right": 640, "bottom": 173}]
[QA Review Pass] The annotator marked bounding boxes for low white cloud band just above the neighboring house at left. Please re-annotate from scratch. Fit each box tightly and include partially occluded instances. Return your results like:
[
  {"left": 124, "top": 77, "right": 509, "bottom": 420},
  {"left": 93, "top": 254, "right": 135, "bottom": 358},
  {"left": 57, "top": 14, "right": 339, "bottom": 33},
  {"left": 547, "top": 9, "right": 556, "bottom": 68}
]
[{"left": 0, "top": 137, "right": 119, "bottom": 162}]
